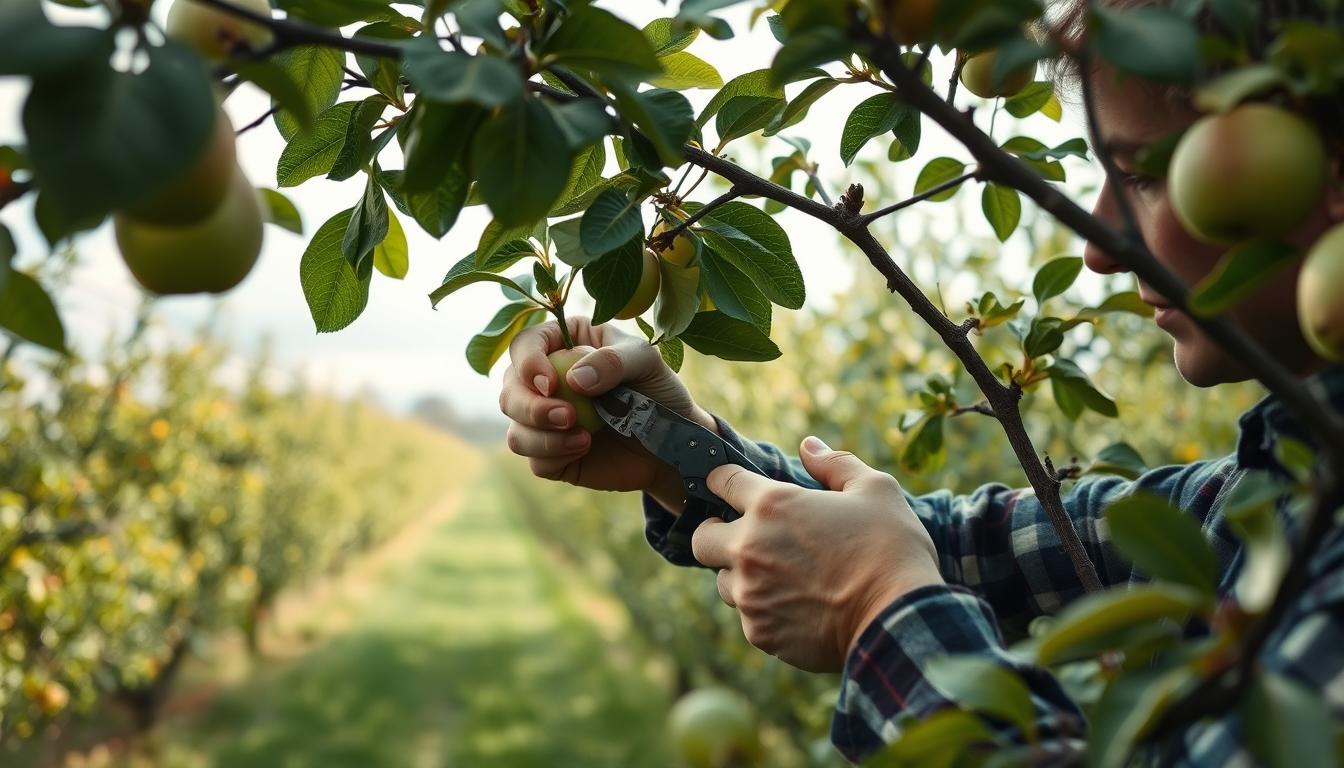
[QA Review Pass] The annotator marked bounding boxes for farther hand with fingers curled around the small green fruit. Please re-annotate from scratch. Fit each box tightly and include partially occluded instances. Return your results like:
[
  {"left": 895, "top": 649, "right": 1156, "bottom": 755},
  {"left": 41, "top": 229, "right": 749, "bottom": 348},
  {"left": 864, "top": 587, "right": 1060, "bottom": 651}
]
[{"left": 500, "top": 317, "right": 716, "bottom": 503}]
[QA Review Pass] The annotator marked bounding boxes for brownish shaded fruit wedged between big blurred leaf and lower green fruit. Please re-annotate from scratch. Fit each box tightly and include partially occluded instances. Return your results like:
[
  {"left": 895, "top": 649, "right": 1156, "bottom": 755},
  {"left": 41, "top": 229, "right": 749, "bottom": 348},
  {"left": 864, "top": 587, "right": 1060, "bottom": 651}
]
[{"left": 125, "top": 109, "right": 238, "bottom": 226}]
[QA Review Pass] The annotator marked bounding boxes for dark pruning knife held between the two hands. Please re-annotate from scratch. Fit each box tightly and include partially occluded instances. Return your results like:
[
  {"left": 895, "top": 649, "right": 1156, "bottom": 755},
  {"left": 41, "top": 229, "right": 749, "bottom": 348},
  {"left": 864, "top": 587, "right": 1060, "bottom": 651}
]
[{"left": 593, "top": 386, "right": 765, "bottom": 525}]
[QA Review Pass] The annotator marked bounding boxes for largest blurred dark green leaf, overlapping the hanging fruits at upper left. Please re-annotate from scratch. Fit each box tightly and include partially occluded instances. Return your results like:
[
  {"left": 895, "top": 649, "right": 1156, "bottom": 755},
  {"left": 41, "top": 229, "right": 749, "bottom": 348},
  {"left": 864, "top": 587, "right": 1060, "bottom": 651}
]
[{"left": 23, "top": 35, "right": 219, "bottom": 219}]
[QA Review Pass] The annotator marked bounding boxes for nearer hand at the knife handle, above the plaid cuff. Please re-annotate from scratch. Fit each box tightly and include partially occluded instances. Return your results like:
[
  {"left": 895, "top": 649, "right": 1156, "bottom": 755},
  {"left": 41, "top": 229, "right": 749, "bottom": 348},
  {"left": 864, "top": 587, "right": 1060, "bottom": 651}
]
[{"left": 691, "top": 437, "right": 942, "bottom": 673}]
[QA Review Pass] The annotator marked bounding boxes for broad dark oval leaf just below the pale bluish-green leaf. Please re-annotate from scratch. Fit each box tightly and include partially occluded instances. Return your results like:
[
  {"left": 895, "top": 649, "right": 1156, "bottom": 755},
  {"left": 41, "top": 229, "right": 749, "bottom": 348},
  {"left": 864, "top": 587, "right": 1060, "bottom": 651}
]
[{"left": 472, "top": 96, "right": 572, "bottom": 225}]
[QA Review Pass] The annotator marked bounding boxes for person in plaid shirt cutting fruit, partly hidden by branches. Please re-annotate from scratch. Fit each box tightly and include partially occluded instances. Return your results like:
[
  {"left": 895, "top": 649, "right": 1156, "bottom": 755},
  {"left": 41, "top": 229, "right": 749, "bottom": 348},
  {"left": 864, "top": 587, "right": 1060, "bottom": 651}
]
[{"left": 500, "top": 1, "right": 1344, "bottom": 765}]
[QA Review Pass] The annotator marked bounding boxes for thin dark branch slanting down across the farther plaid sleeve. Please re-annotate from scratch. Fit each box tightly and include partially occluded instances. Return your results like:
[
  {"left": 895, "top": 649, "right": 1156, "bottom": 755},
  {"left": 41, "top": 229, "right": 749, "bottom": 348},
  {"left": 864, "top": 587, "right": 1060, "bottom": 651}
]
[{"left": 684, "top": 147, "right": 1102, "bottom": 592}]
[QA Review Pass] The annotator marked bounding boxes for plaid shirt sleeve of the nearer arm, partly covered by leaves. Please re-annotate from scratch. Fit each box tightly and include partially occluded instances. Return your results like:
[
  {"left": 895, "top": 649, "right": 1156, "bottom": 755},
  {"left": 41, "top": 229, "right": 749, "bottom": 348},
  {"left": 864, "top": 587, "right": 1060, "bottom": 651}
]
[{"left": 831, "top": 532, "right": 1344, "bottom": 768}]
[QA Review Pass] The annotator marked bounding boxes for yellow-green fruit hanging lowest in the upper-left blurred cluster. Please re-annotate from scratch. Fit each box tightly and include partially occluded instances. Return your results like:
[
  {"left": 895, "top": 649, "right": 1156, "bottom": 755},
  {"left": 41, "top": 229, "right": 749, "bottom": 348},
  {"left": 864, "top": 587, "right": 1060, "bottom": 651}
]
[{"left": 113, "top": 165, "right": 265, "bottom": 295}]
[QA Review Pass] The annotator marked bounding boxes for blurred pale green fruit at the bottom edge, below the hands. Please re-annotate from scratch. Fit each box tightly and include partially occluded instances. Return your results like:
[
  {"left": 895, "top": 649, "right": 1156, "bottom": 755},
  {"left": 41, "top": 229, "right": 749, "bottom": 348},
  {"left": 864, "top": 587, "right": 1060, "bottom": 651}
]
[{"left": 668, "top": 687, "right": 761, "bottom": 768}]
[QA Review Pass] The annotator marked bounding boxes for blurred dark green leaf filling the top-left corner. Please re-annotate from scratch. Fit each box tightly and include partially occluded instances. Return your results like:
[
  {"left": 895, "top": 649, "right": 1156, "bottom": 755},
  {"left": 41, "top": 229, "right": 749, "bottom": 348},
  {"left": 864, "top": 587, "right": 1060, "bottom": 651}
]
[{"left": 0, "top": 0, "right": 105, "bottom": 77}]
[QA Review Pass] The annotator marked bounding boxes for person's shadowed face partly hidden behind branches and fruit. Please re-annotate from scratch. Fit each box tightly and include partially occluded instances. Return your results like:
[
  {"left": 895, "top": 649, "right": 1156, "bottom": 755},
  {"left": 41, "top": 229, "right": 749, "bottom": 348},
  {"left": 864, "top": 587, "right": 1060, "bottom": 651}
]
[{"left": 1083, "top": 70, "right": 1344, "bottom": 386}]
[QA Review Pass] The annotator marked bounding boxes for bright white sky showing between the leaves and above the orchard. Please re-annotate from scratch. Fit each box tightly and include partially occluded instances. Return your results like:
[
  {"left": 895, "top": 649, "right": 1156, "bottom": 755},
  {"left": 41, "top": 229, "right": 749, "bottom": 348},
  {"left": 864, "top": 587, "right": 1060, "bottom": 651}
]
[{"left": 0, "top": 0, "right": 1089, "bottom": 414}]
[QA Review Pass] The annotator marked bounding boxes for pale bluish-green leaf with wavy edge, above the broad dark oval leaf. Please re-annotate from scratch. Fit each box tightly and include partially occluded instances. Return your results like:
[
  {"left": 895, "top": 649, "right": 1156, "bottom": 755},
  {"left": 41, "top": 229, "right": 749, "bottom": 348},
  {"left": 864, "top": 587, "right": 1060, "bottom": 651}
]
[{"left": 402, "top": 38, "right": 523, "bottom": 108}]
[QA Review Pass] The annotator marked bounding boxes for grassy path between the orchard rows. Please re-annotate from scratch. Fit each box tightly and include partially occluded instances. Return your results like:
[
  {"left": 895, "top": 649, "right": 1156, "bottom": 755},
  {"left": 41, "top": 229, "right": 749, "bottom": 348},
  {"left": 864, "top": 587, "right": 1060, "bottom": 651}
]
[{"left": 160, "top": 469, "right": 669, "bottom": 768}]
